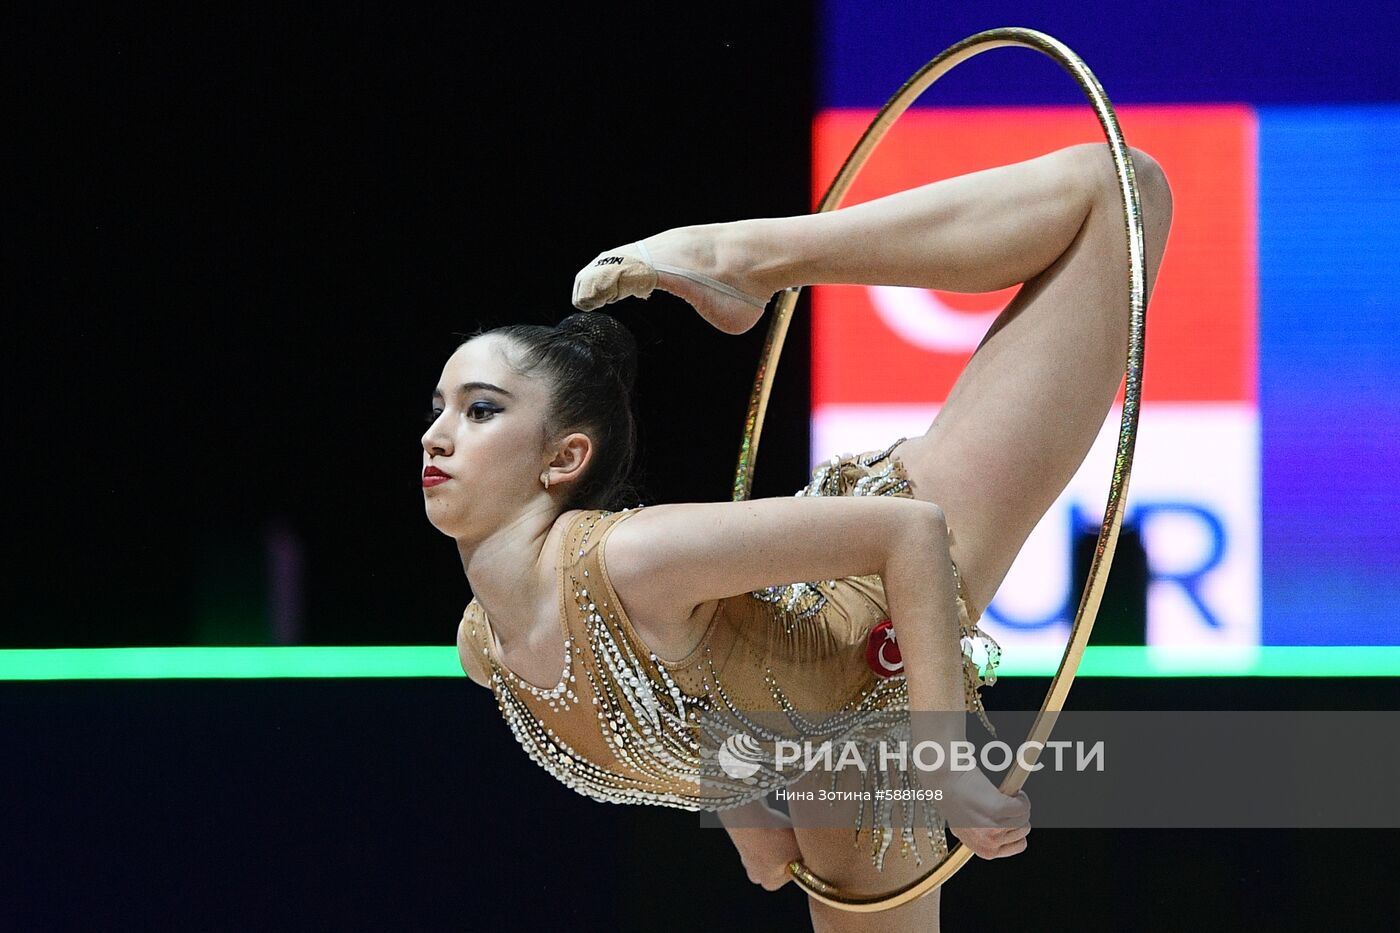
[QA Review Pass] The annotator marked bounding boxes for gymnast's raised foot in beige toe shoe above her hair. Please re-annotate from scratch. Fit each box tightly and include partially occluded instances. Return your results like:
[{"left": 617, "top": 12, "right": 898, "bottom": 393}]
[{"left": 574, "top": 221, "right": 777, "bottom": 333}]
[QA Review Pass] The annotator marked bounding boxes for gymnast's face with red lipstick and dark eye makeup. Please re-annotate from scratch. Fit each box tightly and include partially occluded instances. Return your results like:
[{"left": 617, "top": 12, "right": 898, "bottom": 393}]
[{"left": 423, "top": 335, "right": 549, "bottom": 539}]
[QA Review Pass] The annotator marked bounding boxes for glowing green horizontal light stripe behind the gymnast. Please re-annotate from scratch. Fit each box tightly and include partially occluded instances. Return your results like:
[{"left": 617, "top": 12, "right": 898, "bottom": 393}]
[{"left": 0, "top": 644, "right": 1400, "bottom": 681}]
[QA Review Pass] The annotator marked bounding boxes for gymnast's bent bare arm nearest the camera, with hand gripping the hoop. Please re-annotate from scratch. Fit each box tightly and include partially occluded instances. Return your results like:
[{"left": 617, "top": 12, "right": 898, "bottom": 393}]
[{"left": 606, "top": 496, "right": 1030, "bottom": 859}]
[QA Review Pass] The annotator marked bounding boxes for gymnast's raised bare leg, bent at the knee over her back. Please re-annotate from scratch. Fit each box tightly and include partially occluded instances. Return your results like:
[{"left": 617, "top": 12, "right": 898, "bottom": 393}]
[{"left": 647, "top": 137, "right": 1172, "bottom": 618}]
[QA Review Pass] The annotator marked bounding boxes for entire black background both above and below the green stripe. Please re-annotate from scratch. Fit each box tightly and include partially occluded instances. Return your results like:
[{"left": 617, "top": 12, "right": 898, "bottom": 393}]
[{"left": 10, "top": 7, "right": 1400, "bottom": 932}]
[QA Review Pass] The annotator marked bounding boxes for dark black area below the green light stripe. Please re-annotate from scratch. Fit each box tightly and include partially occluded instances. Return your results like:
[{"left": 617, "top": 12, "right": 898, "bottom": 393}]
[{"left": 10, "top": 678, "right": 1400, "bottom": 933}]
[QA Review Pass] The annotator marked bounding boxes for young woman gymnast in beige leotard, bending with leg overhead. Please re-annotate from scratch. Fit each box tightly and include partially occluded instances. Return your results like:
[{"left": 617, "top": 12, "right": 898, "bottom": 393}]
[{"left": 423, "top": 144, "right": 1172, "bottom": 930}]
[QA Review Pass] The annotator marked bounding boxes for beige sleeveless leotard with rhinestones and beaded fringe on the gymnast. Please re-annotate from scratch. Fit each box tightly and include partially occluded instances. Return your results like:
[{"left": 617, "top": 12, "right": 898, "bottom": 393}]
[{"left": 463, "top": 438, "right": 1000, "bottom": 864}]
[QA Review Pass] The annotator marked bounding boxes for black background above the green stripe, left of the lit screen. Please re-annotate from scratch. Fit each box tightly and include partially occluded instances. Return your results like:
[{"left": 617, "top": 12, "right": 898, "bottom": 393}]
[{"left": 10, "top": 0, "right": 813, "bottom": 647}]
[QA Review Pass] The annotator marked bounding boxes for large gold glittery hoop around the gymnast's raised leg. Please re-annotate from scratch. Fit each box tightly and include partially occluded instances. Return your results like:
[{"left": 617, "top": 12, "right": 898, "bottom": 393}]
[{"left": 734, "top": 27, "right": 1147, "bottom": 912}]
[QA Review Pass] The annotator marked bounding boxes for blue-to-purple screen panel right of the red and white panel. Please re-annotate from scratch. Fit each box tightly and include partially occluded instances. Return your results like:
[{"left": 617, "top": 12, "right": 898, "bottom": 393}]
[{"left": 1259, "top": 105, "right": 1400, "bottom": 644}]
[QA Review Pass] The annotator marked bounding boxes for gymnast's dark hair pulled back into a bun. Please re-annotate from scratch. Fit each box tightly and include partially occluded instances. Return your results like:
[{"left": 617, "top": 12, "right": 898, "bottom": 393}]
[{"left": 468, "top": 311, "right": 641, "bottom": 511}]
